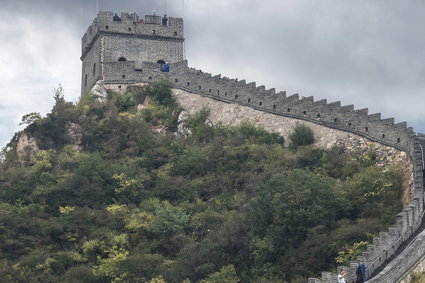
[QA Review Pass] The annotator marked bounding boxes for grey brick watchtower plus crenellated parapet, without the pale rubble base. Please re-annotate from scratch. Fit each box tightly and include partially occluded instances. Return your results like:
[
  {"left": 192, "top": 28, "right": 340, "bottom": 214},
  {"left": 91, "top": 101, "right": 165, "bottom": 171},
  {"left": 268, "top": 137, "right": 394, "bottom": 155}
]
[{"left": 81, "top": 12, "right": 425, "bottom": 282}]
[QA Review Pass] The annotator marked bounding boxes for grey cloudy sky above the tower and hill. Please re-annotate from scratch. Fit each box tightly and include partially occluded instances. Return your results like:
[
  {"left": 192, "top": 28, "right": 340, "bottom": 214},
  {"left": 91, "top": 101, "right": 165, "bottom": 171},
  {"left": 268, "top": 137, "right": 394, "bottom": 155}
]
[{"left": 0, "top": 0, "right": 425, "bottom": 147}]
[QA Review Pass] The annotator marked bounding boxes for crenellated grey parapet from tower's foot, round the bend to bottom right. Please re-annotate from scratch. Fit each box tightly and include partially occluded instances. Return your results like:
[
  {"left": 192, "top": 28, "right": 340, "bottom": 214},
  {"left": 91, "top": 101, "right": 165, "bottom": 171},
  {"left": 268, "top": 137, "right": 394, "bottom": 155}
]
[{"left": 105, "top": 61, "right": 424, "bottom": 282}]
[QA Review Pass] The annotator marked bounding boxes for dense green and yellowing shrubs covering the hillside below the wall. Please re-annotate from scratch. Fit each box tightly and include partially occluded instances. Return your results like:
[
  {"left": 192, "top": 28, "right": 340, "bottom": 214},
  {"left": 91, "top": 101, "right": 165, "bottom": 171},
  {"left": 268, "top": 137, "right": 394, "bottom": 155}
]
[{"left": 0, "top": 82, "right": 403, "bottom": 283}]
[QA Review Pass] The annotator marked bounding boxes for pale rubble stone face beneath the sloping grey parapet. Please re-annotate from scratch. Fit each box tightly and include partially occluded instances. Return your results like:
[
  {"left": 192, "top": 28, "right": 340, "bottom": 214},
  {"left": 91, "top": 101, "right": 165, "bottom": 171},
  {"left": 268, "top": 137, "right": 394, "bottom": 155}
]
[{"left": 173, "top": 89, "right": 414, "bottom": 205}]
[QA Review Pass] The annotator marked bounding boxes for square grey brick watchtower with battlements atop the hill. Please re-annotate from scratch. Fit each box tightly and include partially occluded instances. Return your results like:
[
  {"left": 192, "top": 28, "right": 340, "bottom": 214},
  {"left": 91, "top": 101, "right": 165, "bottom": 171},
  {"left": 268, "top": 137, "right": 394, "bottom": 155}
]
[{"left": 81, "top": 12, "right": 184, "bottom": 94}]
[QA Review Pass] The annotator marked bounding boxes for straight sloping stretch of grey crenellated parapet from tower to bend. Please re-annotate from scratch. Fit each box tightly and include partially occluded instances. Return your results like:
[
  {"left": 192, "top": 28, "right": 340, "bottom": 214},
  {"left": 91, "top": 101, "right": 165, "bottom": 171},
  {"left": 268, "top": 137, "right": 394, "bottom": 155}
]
[{"left": 131, "top": 62, "right": 415, "bottom": 156}]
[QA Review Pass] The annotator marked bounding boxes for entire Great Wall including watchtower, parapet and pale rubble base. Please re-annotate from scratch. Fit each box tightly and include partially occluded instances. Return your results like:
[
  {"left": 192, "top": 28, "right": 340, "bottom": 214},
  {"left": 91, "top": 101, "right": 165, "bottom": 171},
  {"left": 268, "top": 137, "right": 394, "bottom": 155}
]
[{"left": 81, "top": 12, "right": 425, "bottom": 283}]
